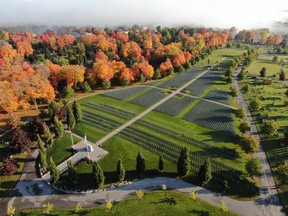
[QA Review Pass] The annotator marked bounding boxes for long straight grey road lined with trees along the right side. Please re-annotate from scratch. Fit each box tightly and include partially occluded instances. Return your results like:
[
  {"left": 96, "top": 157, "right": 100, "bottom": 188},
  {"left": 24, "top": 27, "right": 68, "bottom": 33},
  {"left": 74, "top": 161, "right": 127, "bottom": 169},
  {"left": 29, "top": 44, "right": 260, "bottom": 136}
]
[{"left": 233, "top": 68, "right": 285, "bottom": 216}]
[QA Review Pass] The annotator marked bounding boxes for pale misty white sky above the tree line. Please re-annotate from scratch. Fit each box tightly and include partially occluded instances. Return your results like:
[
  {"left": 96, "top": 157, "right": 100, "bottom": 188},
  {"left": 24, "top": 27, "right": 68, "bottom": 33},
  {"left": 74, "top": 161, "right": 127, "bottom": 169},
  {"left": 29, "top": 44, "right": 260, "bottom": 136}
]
[{"left": 0, "top": 0, "right": 288, "bottom": 29}]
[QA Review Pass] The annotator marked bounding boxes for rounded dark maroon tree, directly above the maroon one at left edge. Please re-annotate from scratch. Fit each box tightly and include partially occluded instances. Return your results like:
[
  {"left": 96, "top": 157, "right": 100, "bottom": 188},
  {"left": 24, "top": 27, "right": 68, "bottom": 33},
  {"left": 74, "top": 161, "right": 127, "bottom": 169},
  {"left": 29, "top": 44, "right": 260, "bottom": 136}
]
[{"left": 9, "top": 128, "right": 32, "bottom": 152}]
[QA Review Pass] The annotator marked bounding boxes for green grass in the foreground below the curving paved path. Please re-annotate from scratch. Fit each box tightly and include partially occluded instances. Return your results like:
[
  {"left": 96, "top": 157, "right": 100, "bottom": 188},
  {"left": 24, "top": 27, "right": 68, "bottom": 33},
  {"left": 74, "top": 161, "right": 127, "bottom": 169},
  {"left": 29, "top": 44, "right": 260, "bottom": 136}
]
[{"left": 15, "top": 191, "right": 237, "bottom": 216}]
